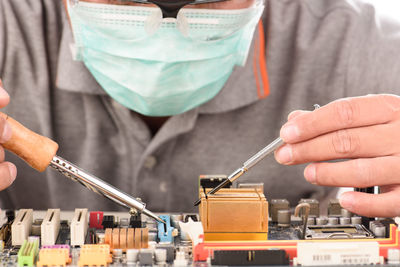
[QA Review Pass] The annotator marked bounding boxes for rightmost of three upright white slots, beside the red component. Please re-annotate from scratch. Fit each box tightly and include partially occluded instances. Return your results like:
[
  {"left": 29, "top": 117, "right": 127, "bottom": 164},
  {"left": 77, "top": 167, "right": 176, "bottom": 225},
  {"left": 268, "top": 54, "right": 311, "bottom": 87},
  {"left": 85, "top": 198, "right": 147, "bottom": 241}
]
[{"left": 71, "top": 209, "right": 88, "bottom": 246}]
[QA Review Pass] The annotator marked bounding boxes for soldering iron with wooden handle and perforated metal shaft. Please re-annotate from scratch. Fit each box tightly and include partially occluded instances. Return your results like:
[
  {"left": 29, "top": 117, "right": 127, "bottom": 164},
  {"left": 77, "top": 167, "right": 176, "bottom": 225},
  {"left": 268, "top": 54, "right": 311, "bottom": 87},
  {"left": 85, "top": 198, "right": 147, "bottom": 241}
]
[{"left": 0, "top": 112, "right": 165, "bottom": 223}]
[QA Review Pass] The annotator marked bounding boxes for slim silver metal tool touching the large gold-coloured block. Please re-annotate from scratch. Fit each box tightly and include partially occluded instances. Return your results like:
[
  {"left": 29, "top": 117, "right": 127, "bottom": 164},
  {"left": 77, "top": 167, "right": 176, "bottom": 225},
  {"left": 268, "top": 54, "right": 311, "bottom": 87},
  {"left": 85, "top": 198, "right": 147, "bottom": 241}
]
[{"left": 194, "top": 137, "right": 283, "bottom": 206}]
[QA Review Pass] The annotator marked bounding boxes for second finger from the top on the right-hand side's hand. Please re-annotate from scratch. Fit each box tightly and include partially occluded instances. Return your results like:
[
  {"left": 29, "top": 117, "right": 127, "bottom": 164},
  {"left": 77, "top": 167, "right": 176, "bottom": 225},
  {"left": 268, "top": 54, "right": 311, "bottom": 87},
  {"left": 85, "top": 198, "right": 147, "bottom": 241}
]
[{"left": 275, "top": 124, "right": 400, "bottom": 165}]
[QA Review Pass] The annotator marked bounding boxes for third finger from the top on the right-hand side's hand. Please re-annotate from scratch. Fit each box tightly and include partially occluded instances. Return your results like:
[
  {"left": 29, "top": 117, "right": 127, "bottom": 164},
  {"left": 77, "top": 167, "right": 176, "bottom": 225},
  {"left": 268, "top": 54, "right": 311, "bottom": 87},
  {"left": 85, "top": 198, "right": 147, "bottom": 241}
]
[{"left": 304, "top": 157, "right": 400, "bottom": 188}]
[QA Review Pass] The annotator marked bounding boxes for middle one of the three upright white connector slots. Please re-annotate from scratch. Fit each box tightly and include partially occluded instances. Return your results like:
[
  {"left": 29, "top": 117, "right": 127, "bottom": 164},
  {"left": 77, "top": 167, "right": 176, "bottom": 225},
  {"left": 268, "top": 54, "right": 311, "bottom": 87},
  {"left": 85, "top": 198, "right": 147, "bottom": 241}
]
[{"left": 40, "top": 209, "right": 60, "bottom": 246}]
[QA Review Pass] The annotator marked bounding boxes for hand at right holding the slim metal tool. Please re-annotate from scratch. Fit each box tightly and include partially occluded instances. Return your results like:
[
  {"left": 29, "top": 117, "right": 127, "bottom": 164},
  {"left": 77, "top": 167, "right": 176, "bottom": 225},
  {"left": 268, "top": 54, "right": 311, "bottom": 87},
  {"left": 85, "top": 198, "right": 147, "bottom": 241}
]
[{"left": 275, "top": 95, "right": 400, "bottom": 217}]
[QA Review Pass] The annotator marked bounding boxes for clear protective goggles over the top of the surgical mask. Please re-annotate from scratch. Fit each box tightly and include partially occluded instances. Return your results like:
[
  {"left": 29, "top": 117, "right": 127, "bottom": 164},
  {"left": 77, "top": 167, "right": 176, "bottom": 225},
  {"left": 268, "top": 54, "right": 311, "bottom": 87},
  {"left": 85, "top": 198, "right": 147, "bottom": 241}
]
[{"left": 69, "top": 0, "right": 264, "bottom": 42}]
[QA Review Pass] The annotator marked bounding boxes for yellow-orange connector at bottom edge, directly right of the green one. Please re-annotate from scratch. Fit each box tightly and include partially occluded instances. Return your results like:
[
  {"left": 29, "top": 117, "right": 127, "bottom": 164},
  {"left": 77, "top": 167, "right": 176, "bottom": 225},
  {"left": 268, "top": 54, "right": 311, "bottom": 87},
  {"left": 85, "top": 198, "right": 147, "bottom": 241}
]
[{"left": 36, "top": 248, "right": 71, "bottom": 267}]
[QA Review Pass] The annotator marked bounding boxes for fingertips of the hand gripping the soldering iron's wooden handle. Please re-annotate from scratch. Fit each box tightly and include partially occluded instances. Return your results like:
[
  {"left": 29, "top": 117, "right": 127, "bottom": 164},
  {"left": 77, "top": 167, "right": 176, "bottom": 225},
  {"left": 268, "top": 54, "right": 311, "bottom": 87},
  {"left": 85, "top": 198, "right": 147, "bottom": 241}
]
[{"left": 0, "top": 80, "right": 17, "bottom": 190}]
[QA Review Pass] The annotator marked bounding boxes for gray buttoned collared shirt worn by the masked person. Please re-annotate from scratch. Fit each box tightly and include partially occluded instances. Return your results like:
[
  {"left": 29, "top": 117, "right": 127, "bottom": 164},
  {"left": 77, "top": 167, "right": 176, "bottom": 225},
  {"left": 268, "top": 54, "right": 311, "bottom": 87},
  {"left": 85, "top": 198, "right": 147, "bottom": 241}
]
[{"left": 0, "top": 0, "right": 400, "bottom": 214}]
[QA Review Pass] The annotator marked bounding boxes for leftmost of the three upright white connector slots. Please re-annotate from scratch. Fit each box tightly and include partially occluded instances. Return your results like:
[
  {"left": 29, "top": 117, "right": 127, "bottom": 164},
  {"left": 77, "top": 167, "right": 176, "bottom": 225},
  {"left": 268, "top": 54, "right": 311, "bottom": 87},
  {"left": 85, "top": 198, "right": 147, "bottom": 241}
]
[{"left": 11, "top": 209, "right": 33, "bottom": 246}]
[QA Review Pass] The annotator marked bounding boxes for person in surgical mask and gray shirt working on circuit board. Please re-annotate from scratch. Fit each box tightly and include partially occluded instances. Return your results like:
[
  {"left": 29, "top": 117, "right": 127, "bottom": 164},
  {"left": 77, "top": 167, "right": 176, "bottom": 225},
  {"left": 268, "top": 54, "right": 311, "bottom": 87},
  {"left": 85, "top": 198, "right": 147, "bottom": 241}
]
[{"left": 0, "top": 0, "right": 400, "bottom": 217}]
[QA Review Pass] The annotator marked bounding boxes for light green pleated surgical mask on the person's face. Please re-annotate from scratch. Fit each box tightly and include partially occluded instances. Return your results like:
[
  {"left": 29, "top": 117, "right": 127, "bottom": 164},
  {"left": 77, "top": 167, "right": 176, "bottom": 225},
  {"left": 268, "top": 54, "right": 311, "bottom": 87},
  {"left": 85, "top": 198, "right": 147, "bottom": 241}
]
[{"left": 68, "top": 0, "right": 263, "bottom": 116}]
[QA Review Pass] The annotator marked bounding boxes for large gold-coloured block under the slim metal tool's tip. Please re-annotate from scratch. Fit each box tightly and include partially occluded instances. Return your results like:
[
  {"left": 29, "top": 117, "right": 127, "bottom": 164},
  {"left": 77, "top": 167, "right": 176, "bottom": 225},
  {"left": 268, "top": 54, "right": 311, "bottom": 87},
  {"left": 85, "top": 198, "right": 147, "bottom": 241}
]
[{"left": 199, "top": 188, "right": 268, "bottom": 241}]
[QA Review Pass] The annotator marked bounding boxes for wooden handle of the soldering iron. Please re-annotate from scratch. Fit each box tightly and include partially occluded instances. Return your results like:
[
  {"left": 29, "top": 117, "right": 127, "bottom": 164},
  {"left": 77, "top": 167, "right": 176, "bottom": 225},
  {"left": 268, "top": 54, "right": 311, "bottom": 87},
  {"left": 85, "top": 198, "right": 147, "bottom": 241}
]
[{"left": 0, "top": 112, "right": 58, "bottom": 172}]
